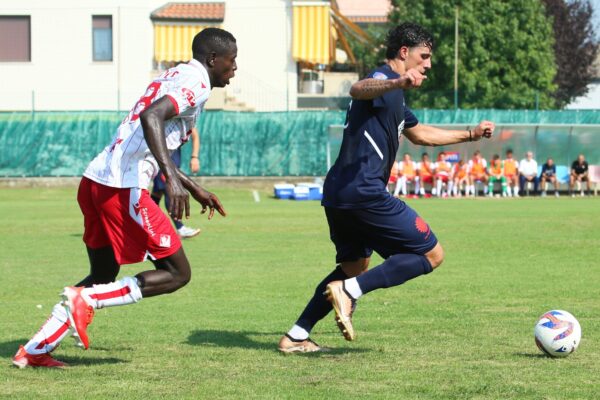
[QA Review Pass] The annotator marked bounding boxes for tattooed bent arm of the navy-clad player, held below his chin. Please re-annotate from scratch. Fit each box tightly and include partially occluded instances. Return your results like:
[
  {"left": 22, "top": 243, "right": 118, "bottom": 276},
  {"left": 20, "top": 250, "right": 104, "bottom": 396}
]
[{"left": 350, "top": 68, "right": 427, "bottom": 100}]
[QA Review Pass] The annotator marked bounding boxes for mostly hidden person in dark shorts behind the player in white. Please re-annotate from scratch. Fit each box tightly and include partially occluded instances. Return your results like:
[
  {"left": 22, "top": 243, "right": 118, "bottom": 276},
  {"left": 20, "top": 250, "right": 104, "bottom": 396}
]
[{"left": 150, "top": 128, "right": 201, "bottom": 239}]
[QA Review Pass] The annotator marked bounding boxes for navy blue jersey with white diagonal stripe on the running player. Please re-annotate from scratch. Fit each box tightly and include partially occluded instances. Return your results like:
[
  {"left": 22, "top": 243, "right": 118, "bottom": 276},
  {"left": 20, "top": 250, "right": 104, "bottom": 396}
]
[{"left": 322, "top": 64, "right": 418, "bottom": 209}]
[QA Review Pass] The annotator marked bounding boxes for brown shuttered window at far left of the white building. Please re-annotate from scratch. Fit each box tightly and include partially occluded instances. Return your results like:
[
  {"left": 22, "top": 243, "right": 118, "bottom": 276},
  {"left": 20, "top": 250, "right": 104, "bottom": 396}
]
[{"left": 0, "top": 15, "right": 31, "bottom": 62}]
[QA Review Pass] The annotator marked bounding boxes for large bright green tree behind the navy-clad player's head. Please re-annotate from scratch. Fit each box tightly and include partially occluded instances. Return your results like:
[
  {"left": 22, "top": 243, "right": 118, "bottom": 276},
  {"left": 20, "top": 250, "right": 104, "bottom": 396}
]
[{"left": 346, "top": 0, "right": 556, "bottom": 109}]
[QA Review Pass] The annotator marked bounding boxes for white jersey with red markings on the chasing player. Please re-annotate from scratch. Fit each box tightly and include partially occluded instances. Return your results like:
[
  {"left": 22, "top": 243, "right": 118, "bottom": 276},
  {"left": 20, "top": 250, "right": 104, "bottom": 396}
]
[{"left": 83, "top": 60, "right": 211, "bottom": 189}]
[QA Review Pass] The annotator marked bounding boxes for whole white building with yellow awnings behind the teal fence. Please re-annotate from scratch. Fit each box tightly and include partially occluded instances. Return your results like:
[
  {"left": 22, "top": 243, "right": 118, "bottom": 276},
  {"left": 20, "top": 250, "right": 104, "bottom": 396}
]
[{"left": 0, "top": 0, "right": 389, "bottom": 111}]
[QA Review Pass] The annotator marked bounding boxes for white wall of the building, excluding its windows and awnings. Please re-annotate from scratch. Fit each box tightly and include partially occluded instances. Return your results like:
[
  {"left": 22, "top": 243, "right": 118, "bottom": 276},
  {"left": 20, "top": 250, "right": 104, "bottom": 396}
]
[{"left": 0, "top": 0, "right": 297, "bottom": 111}]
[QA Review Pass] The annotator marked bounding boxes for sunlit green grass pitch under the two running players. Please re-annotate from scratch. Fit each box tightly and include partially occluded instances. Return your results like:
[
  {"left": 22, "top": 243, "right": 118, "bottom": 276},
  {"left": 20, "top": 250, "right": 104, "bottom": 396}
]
[{"left": 0, "top": 188, "right": 600, "bottom": 400}]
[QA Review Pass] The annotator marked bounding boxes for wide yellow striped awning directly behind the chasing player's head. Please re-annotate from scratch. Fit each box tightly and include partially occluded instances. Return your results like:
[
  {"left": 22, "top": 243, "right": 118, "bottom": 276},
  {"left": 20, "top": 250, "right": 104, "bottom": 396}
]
[{"left": 154, "top": 24, "right": 213, "bottom": 62}]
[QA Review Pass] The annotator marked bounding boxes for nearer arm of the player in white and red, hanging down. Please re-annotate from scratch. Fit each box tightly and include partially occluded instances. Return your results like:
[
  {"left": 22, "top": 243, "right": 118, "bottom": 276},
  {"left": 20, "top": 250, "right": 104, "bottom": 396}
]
[{"left": 140, "top": 96, "right": 190, "bottom": 220}]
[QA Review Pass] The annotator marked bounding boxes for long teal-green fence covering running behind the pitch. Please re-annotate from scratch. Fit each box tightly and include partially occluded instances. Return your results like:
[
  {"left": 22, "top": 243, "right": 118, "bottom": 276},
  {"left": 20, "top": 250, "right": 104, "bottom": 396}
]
[{"left": 0, "top": 110, "right": 600, "bottom": 177}]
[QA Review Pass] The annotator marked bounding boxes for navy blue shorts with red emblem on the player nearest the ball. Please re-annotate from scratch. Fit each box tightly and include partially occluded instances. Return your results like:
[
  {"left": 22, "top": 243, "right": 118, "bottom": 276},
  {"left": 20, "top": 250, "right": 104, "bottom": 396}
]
[{"left": 325, "top": 197, "right": 437, "bottom": 263}]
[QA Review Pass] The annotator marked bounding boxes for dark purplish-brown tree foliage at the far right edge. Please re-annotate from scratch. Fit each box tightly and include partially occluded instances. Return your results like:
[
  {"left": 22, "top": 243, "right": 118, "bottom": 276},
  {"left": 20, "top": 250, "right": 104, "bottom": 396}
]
[{"left": 543, "top": 0, "right": 598, "bottom": 106}]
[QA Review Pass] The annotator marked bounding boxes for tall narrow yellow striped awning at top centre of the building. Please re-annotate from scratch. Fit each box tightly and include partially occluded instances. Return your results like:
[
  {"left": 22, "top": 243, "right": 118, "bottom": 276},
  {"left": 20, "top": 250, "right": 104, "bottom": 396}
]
[{"left": 292, "top": 1, "right": 335, "bottom": 64}]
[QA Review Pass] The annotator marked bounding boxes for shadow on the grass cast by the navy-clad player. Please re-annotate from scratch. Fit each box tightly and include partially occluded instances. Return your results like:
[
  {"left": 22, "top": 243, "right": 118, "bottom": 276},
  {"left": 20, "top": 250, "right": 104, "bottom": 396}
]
[{"left": 187, "top": 330, "right": 369, "bottom": 357}]
